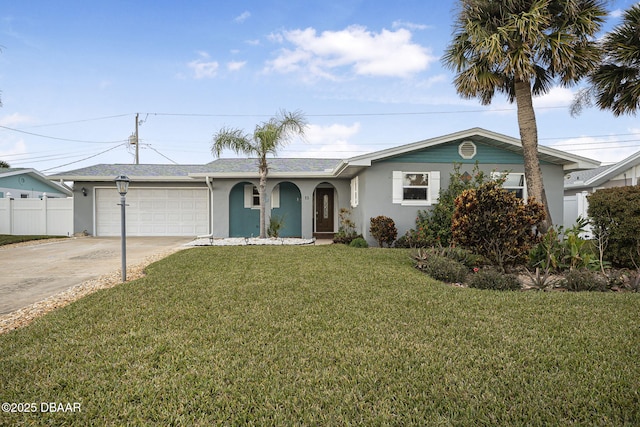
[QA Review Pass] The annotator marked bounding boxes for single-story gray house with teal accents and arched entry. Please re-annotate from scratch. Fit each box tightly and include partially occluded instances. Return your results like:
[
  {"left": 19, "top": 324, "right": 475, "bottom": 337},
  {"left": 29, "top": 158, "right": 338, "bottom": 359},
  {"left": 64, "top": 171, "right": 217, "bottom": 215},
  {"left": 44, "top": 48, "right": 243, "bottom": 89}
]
[{"left": 50, "top": 128, "right": 599, "bottom": 243}]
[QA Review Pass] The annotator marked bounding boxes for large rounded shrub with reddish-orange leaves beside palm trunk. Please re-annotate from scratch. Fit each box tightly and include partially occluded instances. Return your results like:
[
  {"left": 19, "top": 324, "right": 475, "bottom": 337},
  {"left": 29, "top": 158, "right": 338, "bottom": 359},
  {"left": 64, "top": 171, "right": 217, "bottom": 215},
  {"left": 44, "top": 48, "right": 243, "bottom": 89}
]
[{"left": 452, "top": 181, "right": 545, "bottom": 271}]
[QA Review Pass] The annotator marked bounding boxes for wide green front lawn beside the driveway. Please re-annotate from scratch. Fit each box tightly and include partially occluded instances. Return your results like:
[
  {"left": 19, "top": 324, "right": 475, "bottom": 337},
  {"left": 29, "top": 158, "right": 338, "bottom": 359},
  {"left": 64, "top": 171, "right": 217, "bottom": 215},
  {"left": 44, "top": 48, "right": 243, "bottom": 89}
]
[{"left": 0, "top": 245, "right": 640, "bottom": 426}]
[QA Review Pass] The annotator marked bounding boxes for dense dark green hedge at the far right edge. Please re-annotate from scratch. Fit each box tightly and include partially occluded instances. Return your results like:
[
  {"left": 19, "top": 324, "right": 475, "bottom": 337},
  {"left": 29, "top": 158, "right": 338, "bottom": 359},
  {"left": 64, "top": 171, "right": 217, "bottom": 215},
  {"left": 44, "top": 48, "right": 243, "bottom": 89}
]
[{"left": 587, "top": 186, "right": 640, "bottom": 268}]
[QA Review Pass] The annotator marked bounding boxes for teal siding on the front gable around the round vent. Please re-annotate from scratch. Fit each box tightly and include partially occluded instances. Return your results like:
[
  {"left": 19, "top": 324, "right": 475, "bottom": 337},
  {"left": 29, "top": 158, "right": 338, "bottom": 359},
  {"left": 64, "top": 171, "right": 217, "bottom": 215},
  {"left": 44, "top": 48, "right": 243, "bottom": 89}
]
[{"left": 380, "top": 141, "right": 543, "bottom": 164}]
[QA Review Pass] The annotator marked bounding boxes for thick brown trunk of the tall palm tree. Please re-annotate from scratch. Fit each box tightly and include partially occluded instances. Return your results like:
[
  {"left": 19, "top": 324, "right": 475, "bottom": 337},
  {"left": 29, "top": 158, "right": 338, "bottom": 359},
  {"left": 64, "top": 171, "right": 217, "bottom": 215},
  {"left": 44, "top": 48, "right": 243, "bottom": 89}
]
[{"left": 515, "top": 81, "right": 553, "bottom": 233}]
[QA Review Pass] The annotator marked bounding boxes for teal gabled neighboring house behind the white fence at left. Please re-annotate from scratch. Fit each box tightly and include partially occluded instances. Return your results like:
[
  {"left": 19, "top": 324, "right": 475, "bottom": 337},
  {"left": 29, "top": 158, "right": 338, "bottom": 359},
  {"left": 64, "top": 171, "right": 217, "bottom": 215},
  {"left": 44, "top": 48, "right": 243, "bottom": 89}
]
[{"left": 0, "top": 168, "right": 73, "bottom": 199}]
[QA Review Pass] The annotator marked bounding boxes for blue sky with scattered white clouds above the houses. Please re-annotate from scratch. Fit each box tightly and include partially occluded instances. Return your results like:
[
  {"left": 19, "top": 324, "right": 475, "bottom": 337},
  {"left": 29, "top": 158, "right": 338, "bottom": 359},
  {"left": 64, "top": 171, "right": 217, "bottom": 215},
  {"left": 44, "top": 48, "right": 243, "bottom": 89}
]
[{"left": 0, "top": 0, "right": 640, "bottom": 174}]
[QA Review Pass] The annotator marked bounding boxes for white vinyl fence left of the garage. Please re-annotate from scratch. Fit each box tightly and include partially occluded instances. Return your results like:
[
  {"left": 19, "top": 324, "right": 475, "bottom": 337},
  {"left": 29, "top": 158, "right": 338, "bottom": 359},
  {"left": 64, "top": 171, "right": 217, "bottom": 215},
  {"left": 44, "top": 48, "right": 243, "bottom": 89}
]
[{"left": 0, "top": 197, "right": 73, "bottom": 236}]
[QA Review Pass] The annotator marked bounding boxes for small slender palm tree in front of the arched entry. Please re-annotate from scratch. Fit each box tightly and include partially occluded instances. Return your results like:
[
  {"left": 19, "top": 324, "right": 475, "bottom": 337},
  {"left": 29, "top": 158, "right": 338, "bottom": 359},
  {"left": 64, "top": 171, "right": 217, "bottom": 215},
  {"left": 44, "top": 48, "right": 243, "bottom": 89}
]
[{"left": 211, "top": 111, "right": 307, "bottom": 239}]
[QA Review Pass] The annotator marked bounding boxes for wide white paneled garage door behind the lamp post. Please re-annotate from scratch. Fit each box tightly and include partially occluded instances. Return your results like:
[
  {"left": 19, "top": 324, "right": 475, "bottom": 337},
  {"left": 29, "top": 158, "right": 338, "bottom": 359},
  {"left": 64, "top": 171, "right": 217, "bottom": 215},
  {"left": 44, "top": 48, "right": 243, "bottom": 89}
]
[{"left": 96, "top": 188, "right": 209, "bottom": 236}]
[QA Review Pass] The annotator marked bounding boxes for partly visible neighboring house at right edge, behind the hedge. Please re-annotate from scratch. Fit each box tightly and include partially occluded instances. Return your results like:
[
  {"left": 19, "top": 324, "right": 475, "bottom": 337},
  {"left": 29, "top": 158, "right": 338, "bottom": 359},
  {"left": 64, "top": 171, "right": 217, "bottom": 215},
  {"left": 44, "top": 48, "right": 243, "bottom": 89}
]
[{"left": 564, "top": 151, "right": 640, "bottom": 232}]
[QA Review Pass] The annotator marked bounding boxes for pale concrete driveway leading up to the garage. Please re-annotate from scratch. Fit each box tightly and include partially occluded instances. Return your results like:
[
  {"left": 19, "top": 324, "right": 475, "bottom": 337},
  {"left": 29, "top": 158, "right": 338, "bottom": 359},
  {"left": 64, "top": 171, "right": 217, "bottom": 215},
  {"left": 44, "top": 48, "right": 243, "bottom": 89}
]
[{"left": 0, "top": 237, "right": 193, "bottom": 315}]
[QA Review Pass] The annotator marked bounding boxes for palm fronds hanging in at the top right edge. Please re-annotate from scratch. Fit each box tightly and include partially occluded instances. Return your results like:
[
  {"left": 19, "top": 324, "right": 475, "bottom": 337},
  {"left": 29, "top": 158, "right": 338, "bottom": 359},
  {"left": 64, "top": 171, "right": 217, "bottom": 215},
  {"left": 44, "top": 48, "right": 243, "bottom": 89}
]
[{"left": 574, "top": 3, "right": 640, "bottom": 117}]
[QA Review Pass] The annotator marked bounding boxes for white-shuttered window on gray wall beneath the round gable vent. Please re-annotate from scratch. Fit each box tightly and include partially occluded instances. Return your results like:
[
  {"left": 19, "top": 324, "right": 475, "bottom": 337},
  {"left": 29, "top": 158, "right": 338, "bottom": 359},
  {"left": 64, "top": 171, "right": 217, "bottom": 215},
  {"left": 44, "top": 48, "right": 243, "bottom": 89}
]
[{"left": 393, "top": 171, "right": 440, "bottom": 206}]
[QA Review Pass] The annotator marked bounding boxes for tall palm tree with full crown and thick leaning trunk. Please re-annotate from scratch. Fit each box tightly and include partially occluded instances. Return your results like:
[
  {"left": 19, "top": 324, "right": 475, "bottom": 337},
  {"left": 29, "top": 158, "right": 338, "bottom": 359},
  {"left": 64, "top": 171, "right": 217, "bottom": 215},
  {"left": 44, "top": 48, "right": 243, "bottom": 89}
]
[{"left": 443, "top": 0, "right": 606, "bottom": 232}]
